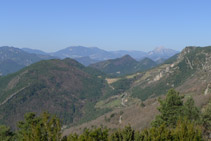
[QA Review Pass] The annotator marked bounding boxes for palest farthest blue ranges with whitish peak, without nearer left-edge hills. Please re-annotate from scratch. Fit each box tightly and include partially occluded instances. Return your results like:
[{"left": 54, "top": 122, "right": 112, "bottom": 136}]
[{"left": 24, "top": 46, "right": 179, "bottom": 65}]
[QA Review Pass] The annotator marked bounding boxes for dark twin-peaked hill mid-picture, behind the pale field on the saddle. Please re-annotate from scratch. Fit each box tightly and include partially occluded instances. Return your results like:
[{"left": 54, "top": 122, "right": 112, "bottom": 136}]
[{"left": 90, "top": 55, "right": 156, "bottom": 76}]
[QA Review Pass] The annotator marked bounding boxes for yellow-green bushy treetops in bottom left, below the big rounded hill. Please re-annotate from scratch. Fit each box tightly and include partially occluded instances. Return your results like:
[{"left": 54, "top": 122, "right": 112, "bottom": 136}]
[{"left": 17, "top": 113, "right": 61, "bottom": 141}]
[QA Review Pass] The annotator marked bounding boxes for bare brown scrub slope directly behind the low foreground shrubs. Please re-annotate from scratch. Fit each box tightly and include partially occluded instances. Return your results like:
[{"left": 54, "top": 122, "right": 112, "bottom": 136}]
[{"left": 63, "top": 99, "right": 159, "bottom": 135}]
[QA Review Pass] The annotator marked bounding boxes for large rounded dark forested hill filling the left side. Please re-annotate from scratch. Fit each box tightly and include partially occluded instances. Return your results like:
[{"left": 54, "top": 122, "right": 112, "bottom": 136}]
[{"left": 0, "top": 59, "right": 108, "bottom": 127}]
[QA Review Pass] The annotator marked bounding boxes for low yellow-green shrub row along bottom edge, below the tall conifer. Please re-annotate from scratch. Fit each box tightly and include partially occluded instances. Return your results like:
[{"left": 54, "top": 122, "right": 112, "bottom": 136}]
[{"left": 64, "top": 120, "right": 203, "bottom": 141}]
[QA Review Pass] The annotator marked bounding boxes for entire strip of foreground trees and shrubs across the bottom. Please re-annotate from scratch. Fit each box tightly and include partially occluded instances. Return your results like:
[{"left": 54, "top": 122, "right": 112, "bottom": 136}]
[{"left": 0, "top": 89, "right": 211, "bottom": 141}]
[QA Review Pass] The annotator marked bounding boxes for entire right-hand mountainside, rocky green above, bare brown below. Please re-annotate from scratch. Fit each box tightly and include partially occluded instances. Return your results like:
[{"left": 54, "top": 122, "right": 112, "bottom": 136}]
[{"left": 63, "top": 47, "right": 211, "bottom": 132}]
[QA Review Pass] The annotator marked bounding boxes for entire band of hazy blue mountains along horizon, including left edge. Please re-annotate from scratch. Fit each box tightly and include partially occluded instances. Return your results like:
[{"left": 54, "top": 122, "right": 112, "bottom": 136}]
[{"left": 0, "top": 46, "right": 178, "bottom": 75}]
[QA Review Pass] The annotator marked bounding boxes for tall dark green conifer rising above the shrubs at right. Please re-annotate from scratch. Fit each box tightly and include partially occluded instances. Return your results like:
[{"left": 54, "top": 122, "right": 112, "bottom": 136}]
[{"left": 152, "top": 89, "right": 200, "bottom": 127}]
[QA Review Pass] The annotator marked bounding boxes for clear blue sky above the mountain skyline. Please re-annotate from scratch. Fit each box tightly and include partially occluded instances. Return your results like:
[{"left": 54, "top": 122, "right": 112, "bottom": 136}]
[{"left": 0, "top": 0, "right": 211, "bottom": 52}]
